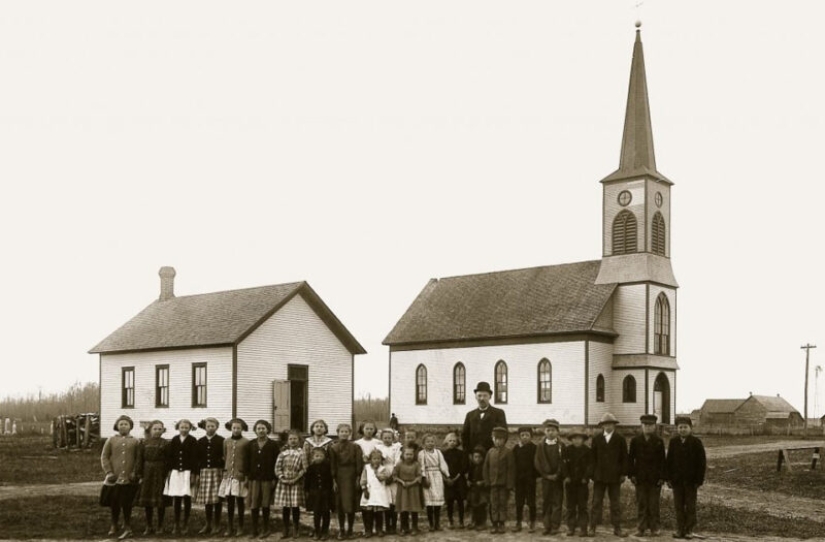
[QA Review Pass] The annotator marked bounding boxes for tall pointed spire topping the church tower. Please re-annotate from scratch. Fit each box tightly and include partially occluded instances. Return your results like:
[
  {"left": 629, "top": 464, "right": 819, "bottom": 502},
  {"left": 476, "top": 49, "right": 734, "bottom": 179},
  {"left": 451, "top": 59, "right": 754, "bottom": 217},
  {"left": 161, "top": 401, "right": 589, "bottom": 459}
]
[{"left": 602, "top": 21, "right": 670, "bottom": 183}]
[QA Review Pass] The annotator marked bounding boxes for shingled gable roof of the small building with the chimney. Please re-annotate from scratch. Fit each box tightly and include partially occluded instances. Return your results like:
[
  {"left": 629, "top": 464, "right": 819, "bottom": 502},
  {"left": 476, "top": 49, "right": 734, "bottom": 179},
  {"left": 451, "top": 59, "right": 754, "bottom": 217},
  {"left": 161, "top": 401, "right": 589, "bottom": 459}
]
[{"left": 89, "top": 282, "right": 366, "bottom": 360}]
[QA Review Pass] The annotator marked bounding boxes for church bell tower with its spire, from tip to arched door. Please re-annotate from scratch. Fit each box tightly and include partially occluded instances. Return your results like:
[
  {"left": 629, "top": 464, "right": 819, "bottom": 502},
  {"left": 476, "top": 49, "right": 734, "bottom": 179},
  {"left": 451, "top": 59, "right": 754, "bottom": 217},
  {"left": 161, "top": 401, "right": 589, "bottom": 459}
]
[{"left": 596, "top": 22, "right": 679, "bottom": 424}]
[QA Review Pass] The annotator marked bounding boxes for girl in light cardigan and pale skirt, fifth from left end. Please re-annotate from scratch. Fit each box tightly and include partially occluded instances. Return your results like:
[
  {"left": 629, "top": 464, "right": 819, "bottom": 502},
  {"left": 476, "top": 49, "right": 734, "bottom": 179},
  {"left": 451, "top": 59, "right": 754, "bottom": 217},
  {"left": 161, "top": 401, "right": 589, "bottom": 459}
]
[{"left": 218, "top": 418, "right": 249, "bottom": 536}]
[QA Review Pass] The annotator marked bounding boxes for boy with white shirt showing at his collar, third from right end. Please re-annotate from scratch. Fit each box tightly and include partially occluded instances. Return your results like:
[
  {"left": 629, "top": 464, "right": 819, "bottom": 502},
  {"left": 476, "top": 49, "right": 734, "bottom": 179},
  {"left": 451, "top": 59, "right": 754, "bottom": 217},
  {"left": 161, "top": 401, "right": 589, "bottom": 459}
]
[{"left": 588, "top": 412, "right": 627, "bottom": 537}]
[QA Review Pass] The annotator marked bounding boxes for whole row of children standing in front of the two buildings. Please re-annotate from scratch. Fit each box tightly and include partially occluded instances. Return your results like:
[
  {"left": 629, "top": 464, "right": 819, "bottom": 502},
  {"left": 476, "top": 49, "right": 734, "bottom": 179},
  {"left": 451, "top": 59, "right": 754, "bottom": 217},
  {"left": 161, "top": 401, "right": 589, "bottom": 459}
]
[{"left": 96, "top": 414, "right": 705, "bottom": 540}]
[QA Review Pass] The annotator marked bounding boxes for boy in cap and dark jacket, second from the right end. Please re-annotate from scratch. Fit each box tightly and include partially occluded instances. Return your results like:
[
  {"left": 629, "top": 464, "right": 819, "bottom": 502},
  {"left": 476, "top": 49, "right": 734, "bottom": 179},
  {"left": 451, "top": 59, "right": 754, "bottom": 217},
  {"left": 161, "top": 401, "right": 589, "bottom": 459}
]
[{"left": 627, "top": 414, "right": 666, "bottom": 536}]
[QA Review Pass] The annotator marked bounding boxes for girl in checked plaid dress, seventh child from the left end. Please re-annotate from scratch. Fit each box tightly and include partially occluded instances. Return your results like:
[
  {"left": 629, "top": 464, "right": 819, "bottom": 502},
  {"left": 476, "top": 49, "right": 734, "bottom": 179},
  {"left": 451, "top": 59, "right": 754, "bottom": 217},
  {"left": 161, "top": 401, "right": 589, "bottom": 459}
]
[{"left": 275, "top": 429, "right": 306, "bottom": 538}]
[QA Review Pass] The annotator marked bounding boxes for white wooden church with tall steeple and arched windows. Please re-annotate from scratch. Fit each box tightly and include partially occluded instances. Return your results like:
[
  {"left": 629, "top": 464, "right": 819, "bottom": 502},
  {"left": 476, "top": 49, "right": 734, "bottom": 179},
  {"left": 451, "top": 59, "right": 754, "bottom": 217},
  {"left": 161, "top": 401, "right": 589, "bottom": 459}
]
[{"left": 383, "top": 25, "right": 679, "bottom": 426}]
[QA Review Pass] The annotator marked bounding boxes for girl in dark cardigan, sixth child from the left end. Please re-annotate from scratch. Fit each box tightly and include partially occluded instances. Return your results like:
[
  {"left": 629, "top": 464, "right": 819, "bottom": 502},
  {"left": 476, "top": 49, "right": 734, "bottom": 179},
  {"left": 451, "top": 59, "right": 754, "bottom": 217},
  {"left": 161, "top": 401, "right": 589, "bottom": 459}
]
[{"left": 247, "top": 420, "right": 281, "bottom": 538}]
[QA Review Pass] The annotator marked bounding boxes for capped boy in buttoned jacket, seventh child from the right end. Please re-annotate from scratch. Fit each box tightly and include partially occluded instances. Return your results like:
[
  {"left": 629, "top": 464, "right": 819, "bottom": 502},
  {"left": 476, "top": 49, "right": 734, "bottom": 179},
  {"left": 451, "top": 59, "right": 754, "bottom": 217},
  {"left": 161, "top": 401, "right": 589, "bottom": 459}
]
[{"left": 484, "top": 427, "right": 516, "bottom": 534}]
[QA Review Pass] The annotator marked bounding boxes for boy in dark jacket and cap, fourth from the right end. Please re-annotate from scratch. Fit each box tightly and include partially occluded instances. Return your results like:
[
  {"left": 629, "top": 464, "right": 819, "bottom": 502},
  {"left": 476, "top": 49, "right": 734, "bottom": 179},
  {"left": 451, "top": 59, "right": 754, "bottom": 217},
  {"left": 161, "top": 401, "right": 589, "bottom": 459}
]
[{"left": 562, "top": 431, "right": 592, "bottom": 536}]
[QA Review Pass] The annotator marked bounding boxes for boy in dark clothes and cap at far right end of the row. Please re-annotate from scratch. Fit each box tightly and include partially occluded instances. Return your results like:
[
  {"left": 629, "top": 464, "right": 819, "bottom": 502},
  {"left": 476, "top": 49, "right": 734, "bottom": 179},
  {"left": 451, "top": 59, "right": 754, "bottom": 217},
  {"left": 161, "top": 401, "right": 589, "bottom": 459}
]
[{"left": 666, "top": 416, "right": 707, "bottom": 539}]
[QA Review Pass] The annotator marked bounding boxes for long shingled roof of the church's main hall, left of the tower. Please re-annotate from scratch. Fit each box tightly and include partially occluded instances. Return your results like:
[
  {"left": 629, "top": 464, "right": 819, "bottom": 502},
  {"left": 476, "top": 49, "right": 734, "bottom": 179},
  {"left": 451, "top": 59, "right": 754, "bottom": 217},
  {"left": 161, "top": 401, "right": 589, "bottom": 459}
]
[{"left": 383, "top": 260, "right": 616, "bottom": 346}]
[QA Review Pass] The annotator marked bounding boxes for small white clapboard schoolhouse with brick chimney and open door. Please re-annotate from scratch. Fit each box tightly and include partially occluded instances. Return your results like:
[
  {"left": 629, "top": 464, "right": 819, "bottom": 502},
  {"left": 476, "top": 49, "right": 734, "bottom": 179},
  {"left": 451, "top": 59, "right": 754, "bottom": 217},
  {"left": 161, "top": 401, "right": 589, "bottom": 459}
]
[{"left": 89, "top": 267, "right": 366, "bottom": 436}]
